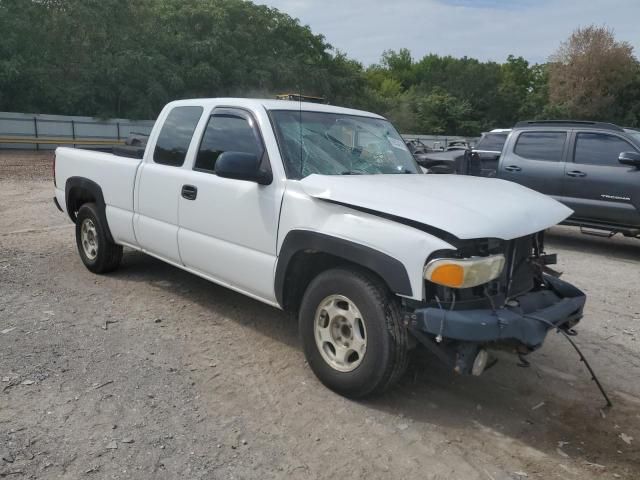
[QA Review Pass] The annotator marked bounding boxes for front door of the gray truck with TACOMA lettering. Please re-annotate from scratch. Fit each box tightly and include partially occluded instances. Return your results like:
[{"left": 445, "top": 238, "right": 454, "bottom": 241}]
[{"left": 560, "top": 128, "right": 640, "bottom": 227}]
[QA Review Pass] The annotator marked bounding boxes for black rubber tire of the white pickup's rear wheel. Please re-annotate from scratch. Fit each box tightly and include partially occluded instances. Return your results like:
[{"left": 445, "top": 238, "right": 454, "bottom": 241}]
[{"left": 76, "top": 203, "right": 122, "bottom": 273}]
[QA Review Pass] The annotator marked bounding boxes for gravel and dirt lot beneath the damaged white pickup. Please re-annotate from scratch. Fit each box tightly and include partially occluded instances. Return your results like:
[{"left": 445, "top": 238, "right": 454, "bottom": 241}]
[{"left": 0, "top": 153, "right": 640, "bottom": 480}]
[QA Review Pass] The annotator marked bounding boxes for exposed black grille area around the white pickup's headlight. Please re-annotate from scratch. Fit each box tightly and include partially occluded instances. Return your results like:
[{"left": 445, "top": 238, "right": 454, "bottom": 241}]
[{"left": 425, "top": 232, "right": 544, "bottom": 310}]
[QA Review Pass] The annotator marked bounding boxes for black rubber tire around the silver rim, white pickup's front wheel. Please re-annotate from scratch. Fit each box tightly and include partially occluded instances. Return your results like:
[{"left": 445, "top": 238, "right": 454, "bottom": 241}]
[{"left": 298, "top": 267, "right": 408, "bottom": 398}]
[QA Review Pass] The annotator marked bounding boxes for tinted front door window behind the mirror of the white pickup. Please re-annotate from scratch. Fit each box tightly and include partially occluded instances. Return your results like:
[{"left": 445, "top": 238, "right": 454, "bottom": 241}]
[{"left": 193, "top": 113, "right": 262, "bottom": 172}]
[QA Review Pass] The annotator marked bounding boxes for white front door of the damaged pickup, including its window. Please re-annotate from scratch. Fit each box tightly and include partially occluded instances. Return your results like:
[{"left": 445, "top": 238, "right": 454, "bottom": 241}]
[{"left": 178, "top": 108, "right": 284, "bottom": 303}]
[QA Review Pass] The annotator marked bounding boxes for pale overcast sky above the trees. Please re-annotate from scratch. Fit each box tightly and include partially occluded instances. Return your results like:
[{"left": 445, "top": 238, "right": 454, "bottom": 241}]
[{"left": 254, "top": 0, "right": 640, "bottom": 66}]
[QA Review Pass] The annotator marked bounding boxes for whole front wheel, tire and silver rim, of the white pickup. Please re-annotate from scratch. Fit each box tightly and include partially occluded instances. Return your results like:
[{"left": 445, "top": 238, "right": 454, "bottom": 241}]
[{"left": 298, "top": 267, "right": 408, "bottom": 398}]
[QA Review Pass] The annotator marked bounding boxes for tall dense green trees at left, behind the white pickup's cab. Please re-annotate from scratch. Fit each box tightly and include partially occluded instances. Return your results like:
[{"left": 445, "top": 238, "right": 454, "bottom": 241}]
[{"left": 0, "top": 0, "right": 366, "bottom": 118}]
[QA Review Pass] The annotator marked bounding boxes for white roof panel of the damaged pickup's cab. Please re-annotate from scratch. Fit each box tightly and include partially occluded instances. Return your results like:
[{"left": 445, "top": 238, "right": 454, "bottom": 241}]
[{"left": 167, "top": 98, "right": 384, "bottom": 118}]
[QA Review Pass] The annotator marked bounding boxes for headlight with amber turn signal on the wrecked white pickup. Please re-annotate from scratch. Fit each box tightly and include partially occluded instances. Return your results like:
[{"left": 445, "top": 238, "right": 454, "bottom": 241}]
[{"left": 424, "top": 254, "right": 505, "bottom": 288}]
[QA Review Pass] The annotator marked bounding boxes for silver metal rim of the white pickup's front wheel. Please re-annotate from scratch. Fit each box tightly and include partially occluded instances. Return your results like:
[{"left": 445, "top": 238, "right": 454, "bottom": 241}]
[{"left": 313, "top": 295, "right": 367, "bottom": 372}]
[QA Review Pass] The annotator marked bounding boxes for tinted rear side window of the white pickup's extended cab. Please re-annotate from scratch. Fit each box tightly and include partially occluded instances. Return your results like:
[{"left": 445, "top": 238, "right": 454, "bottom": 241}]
[{"left": 153, "top": 107, "right": 202, "bottom": 167}]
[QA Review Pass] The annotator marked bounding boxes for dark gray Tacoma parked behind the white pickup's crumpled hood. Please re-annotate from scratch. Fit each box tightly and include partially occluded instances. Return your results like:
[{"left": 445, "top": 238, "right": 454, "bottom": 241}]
[{"left": 488, "top": 120, "right": 640, "bottom": 237}]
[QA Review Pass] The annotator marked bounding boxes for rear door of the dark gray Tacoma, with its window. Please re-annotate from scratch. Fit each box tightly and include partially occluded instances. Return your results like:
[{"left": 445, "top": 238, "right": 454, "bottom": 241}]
[{"left": 497, "top": 128, "right": 569, "bottom": 198}]
